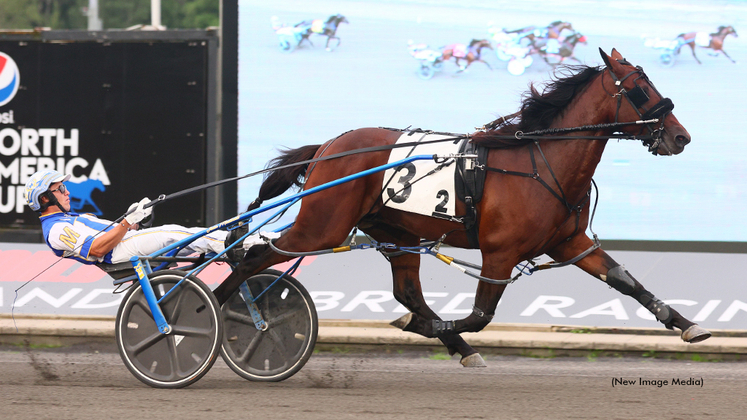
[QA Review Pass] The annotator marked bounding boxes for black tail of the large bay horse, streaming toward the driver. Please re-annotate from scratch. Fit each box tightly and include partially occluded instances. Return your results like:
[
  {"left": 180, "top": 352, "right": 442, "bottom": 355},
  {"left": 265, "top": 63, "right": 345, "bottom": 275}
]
[{"left": 246, "top": 144, "right": 322, "bottom": 211}]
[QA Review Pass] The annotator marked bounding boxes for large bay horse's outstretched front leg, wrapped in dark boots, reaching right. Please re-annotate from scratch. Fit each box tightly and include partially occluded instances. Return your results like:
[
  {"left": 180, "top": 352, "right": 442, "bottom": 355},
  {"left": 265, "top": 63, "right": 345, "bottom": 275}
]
[{"left": 547, "top": 235, "right": 711, "bottom": 343}]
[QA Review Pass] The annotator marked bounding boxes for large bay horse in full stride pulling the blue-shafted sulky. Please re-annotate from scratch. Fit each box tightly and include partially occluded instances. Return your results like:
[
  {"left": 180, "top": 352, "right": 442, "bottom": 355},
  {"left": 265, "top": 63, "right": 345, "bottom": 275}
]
[{"left": 214, "top": 49, "right": 711, "bottom": 366}]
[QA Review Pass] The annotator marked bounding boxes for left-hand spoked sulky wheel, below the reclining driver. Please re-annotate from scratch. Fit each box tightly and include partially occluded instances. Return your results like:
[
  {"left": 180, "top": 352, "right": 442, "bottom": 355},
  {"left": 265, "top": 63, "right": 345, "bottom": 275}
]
[{"left": 115, "top": 270, "right": 223, "bottom": 388}]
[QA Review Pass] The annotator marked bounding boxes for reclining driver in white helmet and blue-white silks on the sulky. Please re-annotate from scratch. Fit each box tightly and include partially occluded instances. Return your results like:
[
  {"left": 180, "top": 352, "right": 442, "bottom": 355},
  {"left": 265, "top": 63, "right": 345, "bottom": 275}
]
[{"left": 23, "top": 170, "right": 279, "bottom": 264}]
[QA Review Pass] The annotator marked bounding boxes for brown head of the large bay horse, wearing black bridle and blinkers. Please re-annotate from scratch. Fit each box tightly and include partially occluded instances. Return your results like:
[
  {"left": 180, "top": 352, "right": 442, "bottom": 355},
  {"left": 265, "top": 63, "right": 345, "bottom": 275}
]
[{"left": 599, "top": 48, "right": 690, "bottom": 155}]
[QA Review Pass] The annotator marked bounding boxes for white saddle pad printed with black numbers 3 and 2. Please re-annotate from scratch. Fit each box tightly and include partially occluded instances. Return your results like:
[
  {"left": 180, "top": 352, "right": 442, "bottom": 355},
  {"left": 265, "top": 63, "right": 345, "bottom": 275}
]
[{"left": 381, "top": 132, "right": 460, "bottom": 219}]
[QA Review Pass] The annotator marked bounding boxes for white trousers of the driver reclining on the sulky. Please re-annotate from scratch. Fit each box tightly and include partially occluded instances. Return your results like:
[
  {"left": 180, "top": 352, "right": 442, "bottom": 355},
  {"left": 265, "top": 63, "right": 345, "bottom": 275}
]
[{"left": 112, "top": 225, "right": 228, "bottom": 264}]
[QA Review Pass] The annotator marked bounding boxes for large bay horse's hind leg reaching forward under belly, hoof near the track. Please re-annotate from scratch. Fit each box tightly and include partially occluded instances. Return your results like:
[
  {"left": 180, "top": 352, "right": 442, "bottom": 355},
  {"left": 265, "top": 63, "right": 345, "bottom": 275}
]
[{"left": 365, "top": 225, "right": 485, "bottom": 367}]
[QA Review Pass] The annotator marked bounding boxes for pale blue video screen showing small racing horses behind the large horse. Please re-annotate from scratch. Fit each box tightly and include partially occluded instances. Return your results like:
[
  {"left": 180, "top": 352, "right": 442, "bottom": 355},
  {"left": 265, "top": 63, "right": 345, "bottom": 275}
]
[{"left": 238, "top": 0, "right": 747, "bottom": 242}]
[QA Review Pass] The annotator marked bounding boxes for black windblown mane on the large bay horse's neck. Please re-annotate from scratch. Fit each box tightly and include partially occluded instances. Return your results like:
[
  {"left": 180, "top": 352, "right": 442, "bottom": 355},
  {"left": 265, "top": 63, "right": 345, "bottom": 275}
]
[{"left": 472, "top": 65, "right": 602, "bottom": 149}]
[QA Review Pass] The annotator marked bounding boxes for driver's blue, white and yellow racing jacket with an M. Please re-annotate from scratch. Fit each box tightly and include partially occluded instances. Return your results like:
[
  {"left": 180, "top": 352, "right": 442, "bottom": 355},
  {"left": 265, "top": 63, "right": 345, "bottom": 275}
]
[{"left": 39, "top": 212, "right": 114, "bottom": 264}]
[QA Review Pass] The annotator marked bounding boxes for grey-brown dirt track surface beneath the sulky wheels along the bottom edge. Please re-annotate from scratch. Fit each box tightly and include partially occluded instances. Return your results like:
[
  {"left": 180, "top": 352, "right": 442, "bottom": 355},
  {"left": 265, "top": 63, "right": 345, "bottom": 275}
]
[{"left": 0, "top": 348, "right": 747, "bottom": 420}]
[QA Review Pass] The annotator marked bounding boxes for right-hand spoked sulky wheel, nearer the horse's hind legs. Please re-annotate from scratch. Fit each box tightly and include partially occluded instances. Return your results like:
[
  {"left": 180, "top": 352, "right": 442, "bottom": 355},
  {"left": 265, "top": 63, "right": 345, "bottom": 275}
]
[{"left": 220, "top": 270, "right": 319, "bottom": 382}]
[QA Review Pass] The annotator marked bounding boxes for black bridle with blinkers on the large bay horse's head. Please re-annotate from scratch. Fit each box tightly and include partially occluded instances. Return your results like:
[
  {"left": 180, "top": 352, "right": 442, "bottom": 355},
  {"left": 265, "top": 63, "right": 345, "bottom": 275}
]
[{"left": 605, "top": 59, "right": 674, "bottom": 154}]
